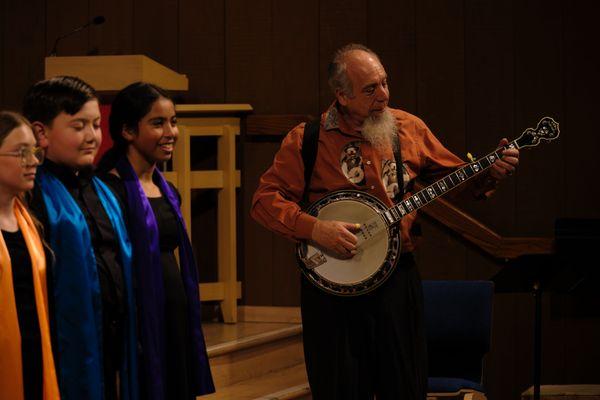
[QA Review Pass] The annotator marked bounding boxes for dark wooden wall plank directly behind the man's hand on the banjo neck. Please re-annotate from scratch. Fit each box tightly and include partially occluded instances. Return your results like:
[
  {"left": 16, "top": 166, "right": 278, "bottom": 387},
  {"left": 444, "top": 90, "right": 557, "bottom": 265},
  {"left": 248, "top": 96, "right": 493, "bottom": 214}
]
[{"left": 461, "top": 4, "right": 517, "bottom": 399}]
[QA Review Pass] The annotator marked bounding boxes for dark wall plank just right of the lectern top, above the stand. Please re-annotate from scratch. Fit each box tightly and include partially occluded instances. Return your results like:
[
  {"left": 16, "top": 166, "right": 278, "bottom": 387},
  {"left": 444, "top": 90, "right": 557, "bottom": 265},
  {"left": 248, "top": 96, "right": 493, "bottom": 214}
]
[{"left": 178, "top": 0, "right": 225, "bottom": 103}]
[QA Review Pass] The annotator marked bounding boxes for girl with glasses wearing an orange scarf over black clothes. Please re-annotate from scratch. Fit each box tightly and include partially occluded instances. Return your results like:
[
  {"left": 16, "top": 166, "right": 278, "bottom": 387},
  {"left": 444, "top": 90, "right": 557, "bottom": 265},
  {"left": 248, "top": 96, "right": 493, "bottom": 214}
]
[{"left": 0, "top": 111, "right": 60, "bottom": 400}]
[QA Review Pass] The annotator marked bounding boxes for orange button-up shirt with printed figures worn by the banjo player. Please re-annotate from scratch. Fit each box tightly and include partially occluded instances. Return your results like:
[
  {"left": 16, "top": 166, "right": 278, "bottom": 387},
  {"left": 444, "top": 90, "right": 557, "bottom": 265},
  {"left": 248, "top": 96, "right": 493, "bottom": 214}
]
[{"left": 251, "top": 104, "right": 489, "bottom": 252}]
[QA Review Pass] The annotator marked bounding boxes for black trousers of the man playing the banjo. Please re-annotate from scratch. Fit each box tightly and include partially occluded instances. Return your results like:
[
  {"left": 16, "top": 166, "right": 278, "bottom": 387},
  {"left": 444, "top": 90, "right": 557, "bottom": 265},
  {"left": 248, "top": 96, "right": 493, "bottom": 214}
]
[{"left": 301, "top": 254, "right": 427, "bottom": 400}]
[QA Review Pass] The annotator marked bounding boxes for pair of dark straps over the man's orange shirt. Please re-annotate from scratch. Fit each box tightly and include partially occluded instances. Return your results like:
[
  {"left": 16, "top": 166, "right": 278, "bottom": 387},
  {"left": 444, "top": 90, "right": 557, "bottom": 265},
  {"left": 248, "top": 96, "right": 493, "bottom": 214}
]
[{"left": 300, "top": 120, "right": 404, "bottom": 207}]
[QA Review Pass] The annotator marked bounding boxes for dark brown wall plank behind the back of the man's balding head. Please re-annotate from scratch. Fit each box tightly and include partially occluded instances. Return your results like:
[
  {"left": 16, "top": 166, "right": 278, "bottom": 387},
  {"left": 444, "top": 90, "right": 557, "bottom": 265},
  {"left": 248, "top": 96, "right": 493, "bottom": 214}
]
[{"left": 319, "top": 0, "right": 368, "bottom": 110}]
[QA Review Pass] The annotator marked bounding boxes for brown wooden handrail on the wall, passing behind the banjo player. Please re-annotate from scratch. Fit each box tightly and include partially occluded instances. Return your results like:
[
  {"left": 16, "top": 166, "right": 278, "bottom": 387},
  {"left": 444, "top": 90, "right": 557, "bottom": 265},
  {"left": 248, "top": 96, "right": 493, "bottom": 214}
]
[{"left": 247, "top": 115, "right": 554, "bottom": 259}]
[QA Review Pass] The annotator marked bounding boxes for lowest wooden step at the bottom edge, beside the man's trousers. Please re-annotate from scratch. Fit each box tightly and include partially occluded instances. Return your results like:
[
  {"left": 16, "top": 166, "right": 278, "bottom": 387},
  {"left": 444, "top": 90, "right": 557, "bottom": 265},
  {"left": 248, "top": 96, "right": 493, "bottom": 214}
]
[{"left": 202, "top": 364, "right": 312, "bottom": 400}]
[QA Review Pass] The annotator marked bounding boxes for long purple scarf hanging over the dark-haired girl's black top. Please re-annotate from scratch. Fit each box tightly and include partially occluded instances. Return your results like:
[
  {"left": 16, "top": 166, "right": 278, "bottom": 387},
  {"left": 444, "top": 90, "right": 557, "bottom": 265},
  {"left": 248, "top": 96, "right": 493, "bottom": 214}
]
[{"left": 116, "top": 157, "right": 215, "bottom": 400}]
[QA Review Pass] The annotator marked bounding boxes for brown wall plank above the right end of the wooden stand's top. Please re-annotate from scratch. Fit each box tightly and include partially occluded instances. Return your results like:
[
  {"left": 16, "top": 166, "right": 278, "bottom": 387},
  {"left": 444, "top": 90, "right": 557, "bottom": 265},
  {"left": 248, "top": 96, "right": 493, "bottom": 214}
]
[{"left": 225, "top": 0, "right": 275, "bottom": 114}]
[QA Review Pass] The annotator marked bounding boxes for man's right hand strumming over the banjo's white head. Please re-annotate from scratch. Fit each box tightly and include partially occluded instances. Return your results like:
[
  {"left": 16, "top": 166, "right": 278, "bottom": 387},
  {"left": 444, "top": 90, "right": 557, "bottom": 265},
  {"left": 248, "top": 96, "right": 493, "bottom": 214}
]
[{"left": 311, "top": 220, "right": 360, "bottom": 258}]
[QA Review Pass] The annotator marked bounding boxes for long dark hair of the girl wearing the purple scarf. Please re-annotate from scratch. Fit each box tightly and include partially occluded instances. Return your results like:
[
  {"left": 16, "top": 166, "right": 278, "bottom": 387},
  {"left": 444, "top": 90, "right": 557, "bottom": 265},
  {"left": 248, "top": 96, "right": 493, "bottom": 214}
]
[{"left": 98, "top": 82, "right": 173, "bottom": 172}]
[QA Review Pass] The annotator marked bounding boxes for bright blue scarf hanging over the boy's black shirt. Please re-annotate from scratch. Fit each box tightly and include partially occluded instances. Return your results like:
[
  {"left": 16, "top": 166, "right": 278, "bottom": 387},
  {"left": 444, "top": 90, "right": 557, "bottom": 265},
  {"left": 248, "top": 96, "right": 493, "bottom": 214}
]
[{"left": 36, "top": 168, "right": 138, "bottom": 400}]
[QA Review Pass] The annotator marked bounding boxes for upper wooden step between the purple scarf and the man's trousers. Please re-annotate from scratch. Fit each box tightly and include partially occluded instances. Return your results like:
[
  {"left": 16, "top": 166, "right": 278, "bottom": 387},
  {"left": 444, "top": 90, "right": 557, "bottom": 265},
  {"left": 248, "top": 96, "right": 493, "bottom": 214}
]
[{"left": 203, "top": 322, "right": 306, "bottom": 390}]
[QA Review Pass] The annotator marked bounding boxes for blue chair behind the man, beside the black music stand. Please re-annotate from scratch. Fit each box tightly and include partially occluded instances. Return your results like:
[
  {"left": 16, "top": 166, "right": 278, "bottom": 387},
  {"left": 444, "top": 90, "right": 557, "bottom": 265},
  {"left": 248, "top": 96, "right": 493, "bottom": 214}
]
[{"left": 423, "top": 281, "right": 494, "bottom": 400}]
